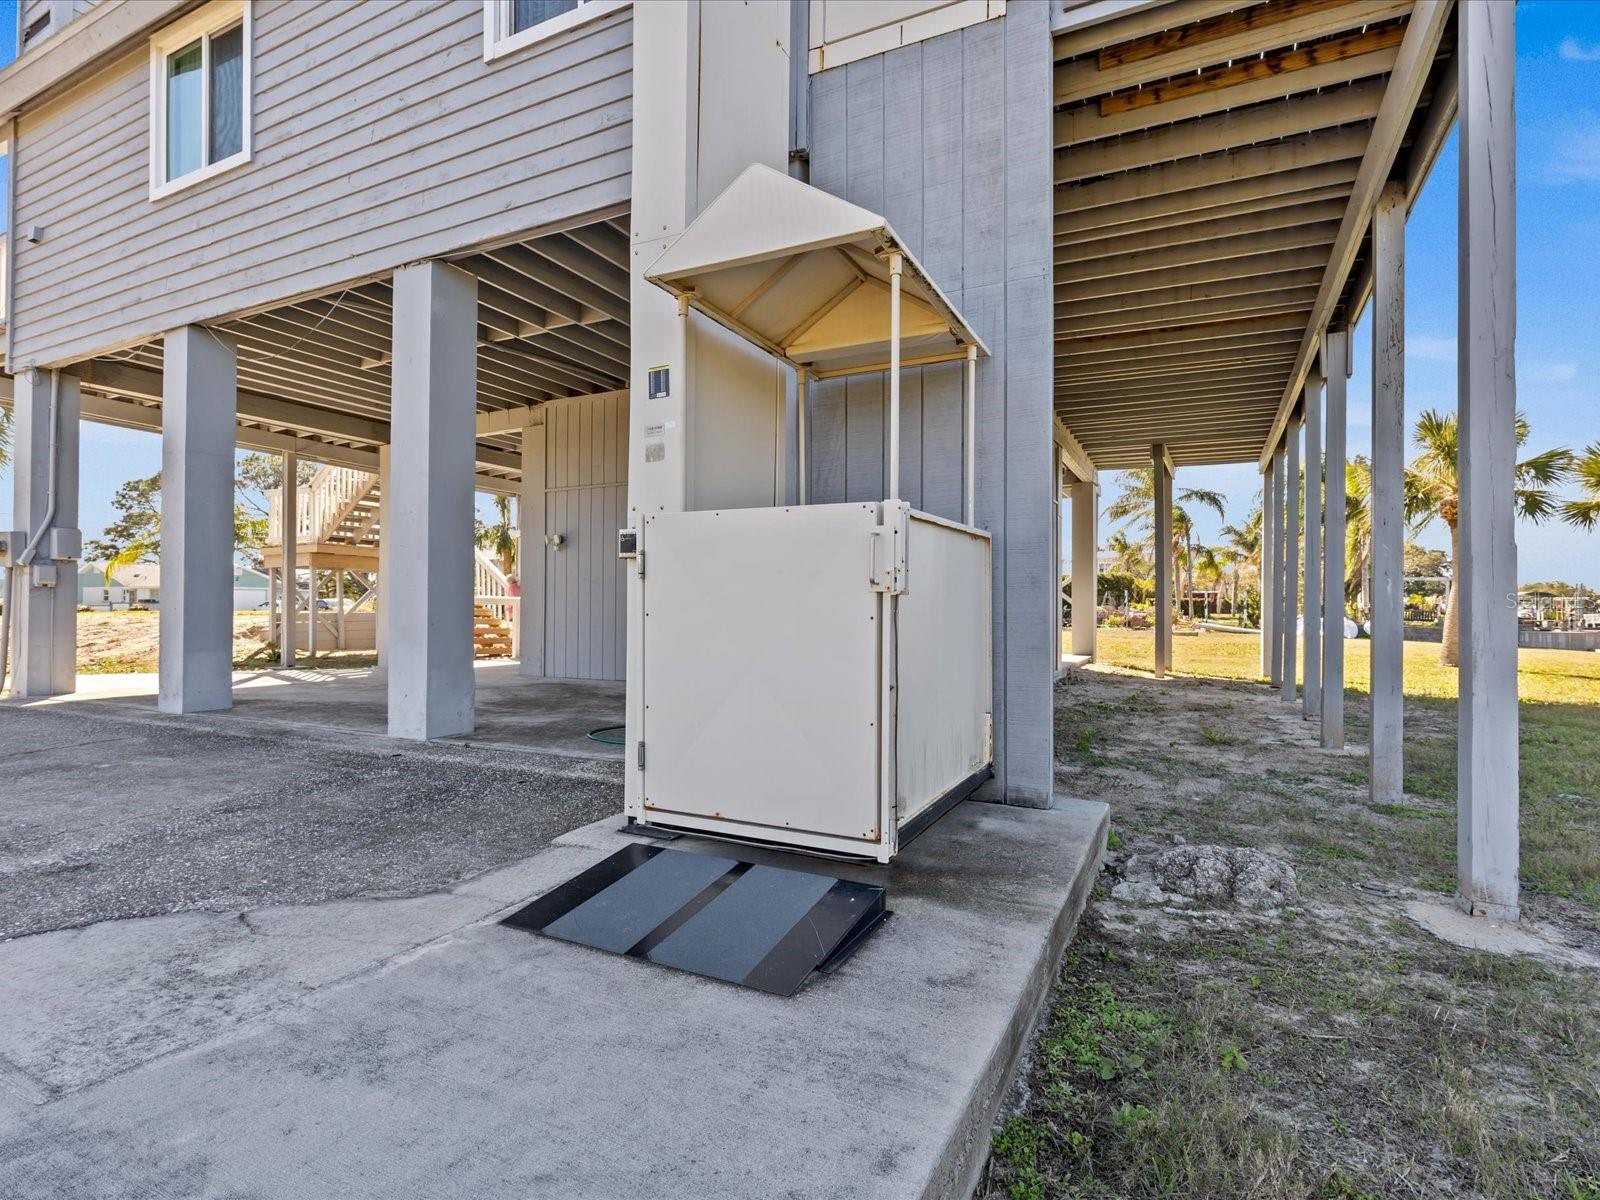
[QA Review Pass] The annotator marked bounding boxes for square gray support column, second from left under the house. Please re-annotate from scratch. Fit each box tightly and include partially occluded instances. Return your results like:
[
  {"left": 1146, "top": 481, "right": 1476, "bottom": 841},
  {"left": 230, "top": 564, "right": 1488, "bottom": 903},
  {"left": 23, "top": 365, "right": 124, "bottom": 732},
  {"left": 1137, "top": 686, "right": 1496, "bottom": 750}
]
[{"left": 158, "top": 325, "right": 238, "bottom": 712}]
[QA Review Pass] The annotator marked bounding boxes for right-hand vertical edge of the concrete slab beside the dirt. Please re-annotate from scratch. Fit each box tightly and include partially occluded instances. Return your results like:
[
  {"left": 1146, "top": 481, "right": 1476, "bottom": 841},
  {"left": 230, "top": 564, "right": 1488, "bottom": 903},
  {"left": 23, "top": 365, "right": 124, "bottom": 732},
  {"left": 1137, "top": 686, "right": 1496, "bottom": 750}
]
[{"left": 920, "top": 800, "right": 1110, "bottom": 1200}]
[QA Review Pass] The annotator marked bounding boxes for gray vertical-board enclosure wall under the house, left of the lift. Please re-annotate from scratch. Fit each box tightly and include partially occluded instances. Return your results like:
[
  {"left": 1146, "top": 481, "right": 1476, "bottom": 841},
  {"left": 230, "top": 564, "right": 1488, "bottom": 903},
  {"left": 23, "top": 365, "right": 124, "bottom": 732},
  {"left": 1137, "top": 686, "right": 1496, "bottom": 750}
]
[{"left": 536, "top": 397, "right": 627, "bottom": 680}]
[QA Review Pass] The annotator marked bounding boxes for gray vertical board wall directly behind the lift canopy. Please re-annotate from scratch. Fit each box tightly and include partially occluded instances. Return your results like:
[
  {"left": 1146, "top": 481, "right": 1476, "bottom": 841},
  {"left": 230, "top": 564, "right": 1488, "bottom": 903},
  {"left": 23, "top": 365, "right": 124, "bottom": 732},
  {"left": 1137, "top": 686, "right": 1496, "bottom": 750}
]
[{"left": 808, "top": 5, "right": 1058, "bottom": 805}]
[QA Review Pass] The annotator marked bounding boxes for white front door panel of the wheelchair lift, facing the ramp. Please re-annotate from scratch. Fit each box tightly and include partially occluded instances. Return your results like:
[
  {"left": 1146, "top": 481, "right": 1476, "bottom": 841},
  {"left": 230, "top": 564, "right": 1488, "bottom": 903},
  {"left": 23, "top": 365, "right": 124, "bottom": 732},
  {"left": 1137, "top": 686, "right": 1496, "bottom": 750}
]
[{"left": 630, "top": 502, "right": 885, "bottom": 854}]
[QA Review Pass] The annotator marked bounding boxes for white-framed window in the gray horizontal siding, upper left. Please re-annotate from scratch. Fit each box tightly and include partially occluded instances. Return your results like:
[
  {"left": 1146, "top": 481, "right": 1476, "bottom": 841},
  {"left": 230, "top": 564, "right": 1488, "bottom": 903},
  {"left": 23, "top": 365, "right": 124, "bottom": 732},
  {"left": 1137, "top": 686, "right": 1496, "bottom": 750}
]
[{"left": 150, "top": 0, "right": 250, "bottom": 200}]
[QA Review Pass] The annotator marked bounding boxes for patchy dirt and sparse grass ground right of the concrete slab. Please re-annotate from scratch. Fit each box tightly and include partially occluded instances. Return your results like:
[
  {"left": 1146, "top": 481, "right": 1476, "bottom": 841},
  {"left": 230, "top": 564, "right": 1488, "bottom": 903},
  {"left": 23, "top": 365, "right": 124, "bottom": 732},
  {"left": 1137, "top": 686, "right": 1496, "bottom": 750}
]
[{"left": 979, "top": 669, "right": 1600, "bottom": 1200}]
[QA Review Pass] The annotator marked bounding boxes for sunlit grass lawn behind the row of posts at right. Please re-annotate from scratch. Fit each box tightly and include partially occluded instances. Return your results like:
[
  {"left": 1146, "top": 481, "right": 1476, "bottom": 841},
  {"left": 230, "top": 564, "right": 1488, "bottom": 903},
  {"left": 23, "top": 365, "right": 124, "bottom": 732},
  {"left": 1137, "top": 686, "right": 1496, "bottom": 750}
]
[{"left": 1075, "top": 629, "right": 1600, "bottom": 909}]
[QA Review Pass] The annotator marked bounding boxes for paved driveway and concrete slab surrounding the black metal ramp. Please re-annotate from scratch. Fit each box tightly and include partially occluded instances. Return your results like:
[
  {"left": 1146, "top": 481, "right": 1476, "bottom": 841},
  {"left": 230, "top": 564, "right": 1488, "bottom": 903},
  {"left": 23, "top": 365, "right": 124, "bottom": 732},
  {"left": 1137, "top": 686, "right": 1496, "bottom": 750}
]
[{"left": 0, "top": 704, "right": 1106, "bottom": 1200}]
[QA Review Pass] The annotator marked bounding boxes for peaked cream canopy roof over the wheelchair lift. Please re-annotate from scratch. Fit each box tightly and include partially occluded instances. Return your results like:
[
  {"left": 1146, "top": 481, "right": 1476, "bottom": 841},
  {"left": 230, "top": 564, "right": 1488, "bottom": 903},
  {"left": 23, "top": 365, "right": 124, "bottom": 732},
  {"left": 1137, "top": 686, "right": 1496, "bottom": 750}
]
[{"left": 646, "top": 163, "right": 989, "bottom": 379}]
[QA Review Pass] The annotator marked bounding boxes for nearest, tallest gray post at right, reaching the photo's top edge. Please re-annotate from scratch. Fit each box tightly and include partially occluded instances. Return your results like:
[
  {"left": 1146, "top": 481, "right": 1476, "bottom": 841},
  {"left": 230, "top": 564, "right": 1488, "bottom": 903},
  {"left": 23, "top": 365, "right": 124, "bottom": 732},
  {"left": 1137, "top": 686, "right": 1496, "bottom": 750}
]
[{"left": 1456, "top": 5, "right": 1520, "bottom": 920}]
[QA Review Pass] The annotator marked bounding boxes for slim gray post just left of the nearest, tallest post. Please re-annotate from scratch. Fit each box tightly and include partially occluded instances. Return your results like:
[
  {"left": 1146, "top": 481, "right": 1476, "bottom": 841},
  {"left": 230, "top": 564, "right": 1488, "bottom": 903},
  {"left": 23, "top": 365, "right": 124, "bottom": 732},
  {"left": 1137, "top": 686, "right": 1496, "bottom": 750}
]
[{"left": 1368, "top": 183, "right": 1408, "bottom": 803}]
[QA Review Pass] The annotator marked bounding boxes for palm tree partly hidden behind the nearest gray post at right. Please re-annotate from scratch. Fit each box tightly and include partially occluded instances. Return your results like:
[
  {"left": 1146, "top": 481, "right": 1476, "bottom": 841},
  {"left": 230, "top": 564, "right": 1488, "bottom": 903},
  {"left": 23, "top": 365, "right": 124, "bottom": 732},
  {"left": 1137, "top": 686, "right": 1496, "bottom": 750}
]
[{"left": 1405, "top": 408, "right": 1573, "bottom": 667}]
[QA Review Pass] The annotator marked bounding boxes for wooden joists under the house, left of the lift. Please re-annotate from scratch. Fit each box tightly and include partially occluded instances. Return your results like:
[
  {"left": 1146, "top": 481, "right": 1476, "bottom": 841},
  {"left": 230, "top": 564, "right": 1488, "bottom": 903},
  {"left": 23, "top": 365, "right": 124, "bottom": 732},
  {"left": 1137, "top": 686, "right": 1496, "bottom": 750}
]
[{"left": 60, "top": 218, "right": 629, "bottom": 490}]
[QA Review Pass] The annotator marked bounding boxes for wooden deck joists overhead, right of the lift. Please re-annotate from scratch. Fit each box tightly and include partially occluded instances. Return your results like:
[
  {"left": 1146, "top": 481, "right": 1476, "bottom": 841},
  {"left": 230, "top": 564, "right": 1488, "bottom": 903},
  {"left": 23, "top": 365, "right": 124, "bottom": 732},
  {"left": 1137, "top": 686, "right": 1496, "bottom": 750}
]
[{"left": 1053, "top": 0, "right": 1450, "bottom": 469}]
